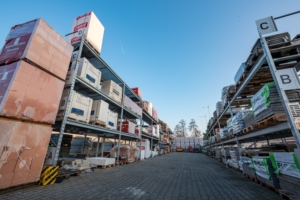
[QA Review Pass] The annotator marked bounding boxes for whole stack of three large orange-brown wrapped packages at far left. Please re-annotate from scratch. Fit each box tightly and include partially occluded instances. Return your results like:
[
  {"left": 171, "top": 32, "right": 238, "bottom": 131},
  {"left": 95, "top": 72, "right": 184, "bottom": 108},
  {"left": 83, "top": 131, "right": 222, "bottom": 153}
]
[{"left": 0, "top": 19, "right": 73, "bottom": 189}]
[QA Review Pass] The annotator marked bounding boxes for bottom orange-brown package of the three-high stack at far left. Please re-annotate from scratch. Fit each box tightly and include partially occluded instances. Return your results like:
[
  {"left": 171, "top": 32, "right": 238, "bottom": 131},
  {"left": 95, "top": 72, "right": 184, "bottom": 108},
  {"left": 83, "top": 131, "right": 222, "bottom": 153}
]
[{"left": 0, "top": 118, "right": 52, "bottom": 189}]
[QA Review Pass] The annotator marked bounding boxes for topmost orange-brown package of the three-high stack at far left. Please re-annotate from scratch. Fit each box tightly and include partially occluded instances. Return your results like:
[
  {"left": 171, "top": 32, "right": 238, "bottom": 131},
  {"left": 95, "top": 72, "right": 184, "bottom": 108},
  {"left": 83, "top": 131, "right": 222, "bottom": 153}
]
[{"left": 0, "top": 18, "right": 73, "bottom": 80}]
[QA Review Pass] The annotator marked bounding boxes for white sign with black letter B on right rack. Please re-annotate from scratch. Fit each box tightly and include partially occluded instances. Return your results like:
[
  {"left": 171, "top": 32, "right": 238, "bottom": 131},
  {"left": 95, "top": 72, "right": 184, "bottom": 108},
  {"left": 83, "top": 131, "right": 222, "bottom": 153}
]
[{"left": 275, "top": 68, "right": 300, "bottom": 90}]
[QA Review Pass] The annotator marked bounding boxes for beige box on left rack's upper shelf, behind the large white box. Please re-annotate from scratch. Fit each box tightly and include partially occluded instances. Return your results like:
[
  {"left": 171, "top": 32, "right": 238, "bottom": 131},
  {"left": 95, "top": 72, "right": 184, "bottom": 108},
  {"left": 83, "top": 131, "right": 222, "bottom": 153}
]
[{"left": 101, "top": 80, "right": 122, "bottom": 103}]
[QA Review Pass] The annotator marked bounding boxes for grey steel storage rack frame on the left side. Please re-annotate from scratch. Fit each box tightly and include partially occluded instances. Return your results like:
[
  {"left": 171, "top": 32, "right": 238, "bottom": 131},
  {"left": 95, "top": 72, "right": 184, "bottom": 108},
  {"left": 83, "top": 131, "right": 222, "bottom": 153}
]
[{"left": 53, "top": 39, "right": 163, "bottom": 166}]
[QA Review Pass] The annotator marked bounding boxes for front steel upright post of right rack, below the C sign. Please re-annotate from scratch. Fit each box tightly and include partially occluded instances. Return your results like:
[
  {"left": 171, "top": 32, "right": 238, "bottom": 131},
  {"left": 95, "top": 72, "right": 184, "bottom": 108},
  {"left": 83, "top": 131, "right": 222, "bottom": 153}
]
[{"left": 259, "top": 34, "right": 300, "bottom": 160}]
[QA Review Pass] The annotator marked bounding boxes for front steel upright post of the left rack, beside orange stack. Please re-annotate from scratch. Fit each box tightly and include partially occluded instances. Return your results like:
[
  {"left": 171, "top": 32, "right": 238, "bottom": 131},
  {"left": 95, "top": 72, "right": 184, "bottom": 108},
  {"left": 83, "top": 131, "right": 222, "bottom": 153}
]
[{"left": 53, "top": 37, "right": 85, "bottom": 166}]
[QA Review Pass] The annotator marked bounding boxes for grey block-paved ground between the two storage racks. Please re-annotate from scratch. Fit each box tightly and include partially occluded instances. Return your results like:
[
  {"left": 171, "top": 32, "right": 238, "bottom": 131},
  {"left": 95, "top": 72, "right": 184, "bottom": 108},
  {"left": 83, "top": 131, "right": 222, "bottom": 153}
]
[{"left": 0, "top": 153, "right": 280, "bottom": 200}]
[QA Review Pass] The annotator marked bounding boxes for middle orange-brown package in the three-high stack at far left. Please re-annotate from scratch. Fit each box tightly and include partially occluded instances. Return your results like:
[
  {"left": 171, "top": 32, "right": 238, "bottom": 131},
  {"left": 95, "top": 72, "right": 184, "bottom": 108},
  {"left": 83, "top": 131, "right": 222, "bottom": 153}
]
[{"left": 0, "top": 61, "right": 64, "bottom": 124}]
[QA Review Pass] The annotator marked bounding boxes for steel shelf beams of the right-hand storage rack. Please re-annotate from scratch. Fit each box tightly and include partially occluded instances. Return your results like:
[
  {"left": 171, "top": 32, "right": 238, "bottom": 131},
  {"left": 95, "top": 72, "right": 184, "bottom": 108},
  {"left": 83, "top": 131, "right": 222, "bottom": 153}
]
[{"left": 205, "top": 32, "right": 300, "bottom": 156}]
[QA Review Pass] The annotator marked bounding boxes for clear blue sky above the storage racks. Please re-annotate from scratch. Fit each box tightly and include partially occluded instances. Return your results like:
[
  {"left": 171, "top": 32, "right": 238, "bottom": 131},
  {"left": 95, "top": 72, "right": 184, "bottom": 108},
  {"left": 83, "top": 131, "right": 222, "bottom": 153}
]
[{"left": 0, "top": 0, "right": 300, "bottom": 135}]
